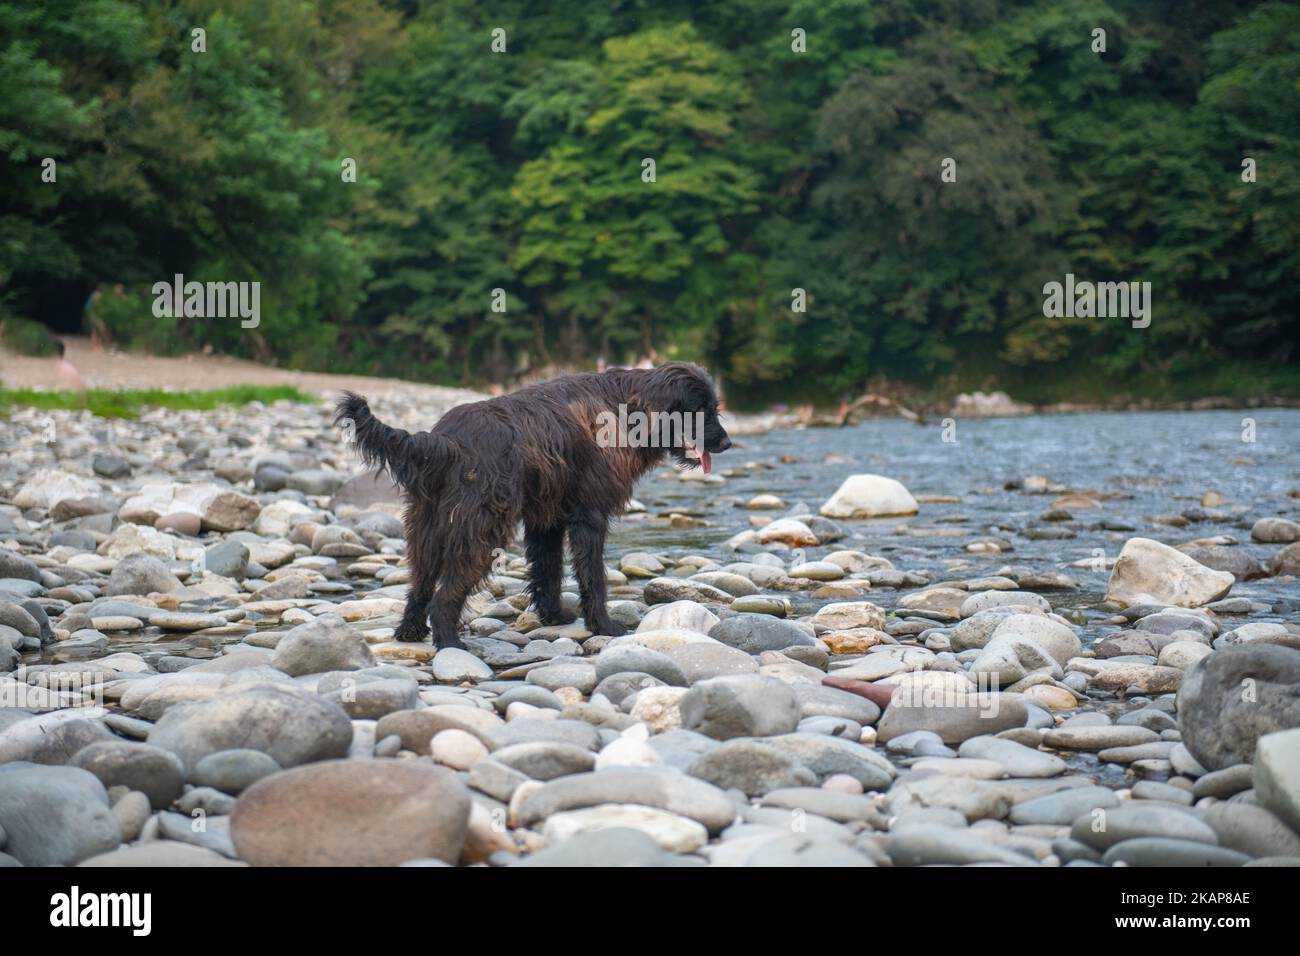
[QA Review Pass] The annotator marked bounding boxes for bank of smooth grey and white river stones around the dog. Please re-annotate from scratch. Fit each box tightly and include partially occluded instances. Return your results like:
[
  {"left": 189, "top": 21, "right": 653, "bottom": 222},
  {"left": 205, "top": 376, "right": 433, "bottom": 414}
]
[{"left": 0, "top": 394, "right": 1300, "bottom": 866}]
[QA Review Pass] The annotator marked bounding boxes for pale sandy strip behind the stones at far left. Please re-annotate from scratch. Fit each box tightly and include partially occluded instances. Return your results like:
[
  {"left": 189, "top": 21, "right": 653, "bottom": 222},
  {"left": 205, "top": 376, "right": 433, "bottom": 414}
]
[{"left": 0, "top": 336, "right": 485, "bottom": 405}]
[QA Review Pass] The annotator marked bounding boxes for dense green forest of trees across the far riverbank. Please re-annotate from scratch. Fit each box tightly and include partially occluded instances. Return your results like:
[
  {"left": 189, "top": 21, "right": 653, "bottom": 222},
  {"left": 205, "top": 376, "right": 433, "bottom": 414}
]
[{"left": 0, "top": 0, "right": 1300, "bottom": 407}]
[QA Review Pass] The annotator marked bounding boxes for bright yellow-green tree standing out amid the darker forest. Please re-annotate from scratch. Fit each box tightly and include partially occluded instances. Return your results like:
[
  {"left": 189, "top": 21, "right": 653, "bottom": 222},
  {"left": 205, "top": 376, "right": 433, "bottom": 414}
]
[{"left": 511, "top": 25, "right": 758, "bottom": 358}]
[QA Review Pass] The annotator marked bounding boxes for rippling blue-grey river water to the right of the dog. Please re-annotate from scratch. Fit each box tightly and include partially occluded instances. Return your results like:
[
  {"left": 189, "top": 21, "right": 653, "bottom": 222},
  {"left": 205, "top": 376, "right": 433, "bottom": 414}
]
[{"left": 608, "top": 408, "right": 1300, "bottom": 632}]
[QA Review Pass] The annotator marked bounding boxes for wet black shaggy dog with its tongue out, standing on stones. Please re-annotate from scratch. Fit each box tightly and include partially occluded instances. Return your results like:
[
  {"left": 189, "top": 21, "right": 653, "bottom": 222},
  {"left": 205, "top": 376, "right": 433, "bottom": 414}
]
[{"left": 335, "top": 362, "right": 731, "bottom": 648}]
